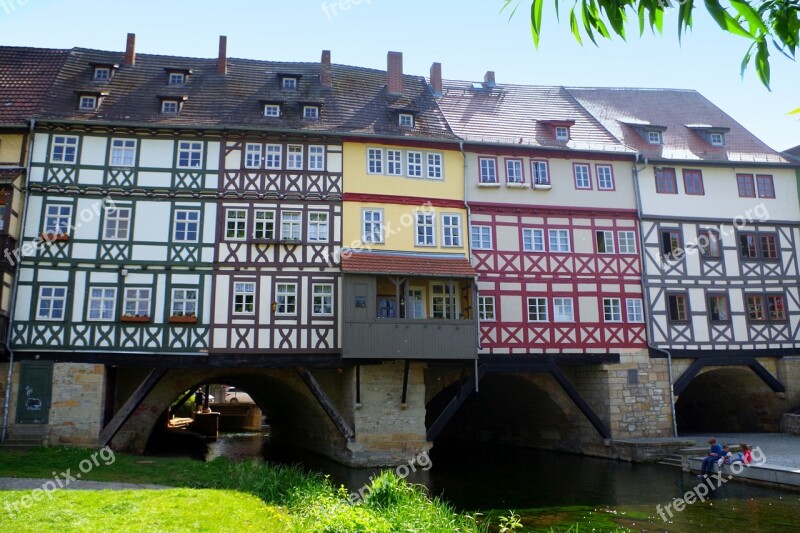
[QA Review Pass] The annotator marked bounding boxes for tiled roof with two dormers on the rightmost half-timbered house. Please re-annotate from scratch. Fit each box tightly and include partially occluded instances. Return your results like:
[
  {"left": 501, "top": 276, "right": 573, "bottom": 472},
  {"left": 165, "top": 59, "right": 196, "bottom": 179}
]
[{"left": 567, "top": 87, "right": 789, "bottom": 164}]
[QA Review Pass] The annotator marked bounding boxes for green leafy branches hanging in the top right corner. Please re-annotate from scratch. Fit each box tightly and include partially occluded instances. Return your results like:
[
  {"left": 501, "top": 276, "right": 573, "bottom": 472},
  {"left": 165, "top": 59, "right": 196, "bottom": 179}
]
[{"left": 502, "top": 0, "right": 800, "bottom": 90}]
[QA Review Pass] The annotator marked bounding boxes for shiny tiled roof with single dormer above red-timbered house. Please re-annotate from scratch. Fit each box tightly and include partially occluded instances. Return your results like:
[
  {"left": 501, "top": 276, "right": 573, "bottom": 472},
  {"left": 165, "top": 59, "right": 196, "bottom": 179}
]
[{"left": 439, "top": 81, "right": 626, "bottom": 152}]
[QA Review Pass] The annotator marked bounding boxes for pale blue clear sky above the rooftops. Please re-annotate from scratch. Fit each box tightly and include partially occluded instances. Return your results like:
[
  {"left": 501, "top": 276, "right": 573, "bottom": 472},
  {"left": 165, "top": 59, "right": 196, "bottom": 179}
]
[{"left": 0, "top": 0, "right": 800, "bottom": 150}]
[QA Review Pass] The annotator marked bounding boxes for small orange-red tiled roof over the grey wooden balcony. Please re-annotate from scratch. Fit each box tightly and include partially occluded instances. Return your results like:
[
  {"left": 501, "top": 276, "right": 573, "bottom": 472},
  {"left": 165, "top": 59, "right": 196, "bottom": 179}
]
[{"left": 342, "top": 252, "right": 478, "bottom": 278}]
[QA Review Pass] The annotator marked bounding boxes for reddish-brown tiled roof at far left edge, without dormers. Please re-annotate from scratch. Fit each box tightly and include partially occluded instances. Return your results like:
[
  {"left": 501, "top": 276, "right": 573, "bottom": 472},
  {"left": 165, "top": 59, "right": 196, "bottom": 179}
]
[{"left": 0, "top": 46, "right": 69, "bottom": 126}]
